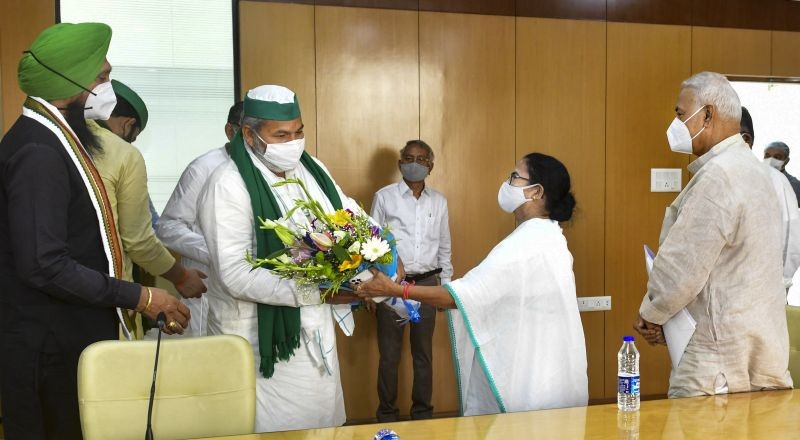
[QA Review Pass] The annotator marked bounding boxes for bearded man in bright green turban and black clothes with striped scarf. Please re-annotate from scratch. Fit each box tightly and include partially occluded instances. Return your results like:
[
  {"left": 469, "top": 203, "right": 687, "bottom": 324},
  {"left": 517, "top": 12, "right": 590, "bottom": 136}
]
[{"left": 0, "top": 23, "right": 189, "bottom": 439}]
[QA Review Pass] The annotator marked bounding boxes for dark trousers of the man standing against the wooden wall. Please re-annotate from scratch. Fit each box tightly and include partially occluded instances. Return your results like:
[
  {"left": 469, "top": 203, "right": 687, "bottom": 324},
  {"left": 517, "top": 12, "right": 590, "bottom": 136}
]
[{"left": 375, "top": 275, "right": 439, "bottom": 422}]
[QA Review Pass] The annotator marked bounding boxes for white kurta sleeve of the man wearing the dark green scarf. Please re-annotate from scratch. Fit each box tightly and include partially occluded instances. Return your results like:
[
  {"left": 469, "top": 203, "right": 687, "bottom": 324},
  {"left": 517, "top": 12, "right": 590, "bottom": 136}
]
[{"left": 198, "top": 165, "right": 306, "bottom": 307}]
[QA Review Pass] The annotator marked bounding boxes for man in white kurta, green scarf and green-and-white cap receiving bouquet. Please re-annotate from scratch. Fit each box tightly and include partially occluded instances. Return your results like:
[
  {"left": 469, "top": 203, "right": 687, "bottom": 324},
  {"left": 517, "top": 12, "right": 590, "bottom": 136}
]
[{"left": 197, "top": 85, "right": 363, "bottom": 432}]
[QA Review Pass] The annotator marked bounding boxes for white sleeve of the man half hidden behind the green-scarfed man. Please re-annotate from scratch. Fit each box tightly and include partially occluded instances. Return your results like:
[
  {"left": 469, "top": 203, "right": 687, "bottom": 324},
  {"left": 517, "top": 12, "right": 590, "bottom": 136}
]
[{"left": 156, "top": 164, "right": 210, "bottom": 265}]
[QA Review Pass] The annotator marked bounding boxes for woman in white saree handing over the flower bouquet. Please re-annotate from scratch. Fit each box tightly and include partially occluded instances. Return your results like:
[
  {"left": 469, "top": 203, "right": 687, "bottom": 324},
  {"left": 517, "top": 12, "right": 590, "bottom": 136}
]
[{"left": 357, "top": 153, "right": 588, "bottom": 416}]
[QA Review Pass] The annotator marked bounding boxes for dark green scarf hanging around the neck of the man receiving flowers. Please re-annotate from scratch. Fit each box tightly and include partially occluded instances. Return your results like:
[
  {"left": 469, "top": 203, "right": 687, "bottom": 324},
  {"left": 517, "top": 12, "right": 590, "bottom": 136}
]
[{"left": 231, "top": 130, "right": 342, "bottom": 379}]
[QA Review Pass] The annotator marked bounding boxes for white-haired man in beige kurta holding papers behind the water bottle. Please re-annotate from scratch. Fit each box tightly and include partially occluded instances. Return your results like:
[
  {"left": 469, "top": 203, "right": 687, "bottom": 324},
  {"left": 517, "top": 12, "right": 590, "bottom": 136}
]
[{"left": 635, "top": 72, "right": 792, "bottom": 397}]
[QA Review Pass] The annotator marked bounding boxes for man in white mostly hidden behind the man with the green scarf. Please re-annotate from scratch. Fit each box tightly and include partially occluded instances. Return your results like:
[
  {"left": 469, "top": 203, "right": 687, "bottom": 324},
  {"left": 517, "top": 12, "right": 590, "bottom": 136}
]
[{"left": 156, "top": 101, "right": 242, "bottom": 336}]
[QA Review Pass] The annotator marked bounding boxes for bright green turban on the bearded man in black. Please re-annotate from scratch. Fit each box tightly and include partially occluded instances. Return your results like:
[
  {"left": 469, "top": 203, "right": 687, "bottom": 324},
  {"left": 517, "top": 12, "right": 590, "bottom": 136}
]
[{"left": 17, "top": 23, "right": 111, "bottom": 101}]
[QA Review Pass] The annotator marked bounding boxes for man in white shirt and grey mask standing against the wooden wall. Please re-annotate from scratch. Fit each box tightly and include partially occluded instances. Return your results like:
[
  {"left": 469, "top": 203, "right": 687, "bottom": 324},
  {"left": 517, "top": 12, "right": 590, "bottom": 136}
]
[{"left": 372, "top": 140, "right": 453, "bottom": 422}]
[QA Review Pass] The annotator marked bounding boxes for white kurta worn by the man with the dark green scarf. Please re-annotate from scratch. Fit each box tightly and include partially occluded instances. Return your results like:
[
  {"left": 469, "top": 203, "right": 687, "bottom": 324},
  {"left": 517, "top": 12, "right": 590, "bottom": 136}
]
[{"left": 198, "top": 151, "right": 361, "bottom": 432}]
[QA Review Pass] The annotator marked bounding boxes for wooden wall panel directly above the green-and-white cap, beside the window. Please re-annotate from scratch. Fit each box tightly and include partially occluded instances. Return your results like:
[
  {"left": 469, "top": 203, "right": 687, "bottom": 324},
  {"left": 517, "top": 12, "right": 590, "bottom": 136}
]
[{"left": 239, "top": 1, "right": 317, "bottom": 154}]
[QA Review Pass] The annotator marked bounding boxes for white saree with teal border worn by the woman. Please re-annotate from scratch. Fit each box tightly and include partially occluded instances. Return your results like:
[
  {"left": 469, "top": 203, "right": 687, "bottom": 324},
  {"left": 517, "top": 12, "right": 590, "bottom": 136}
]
[{"left": 447, "top": 219, "right": 589, "bottom": 416}]
